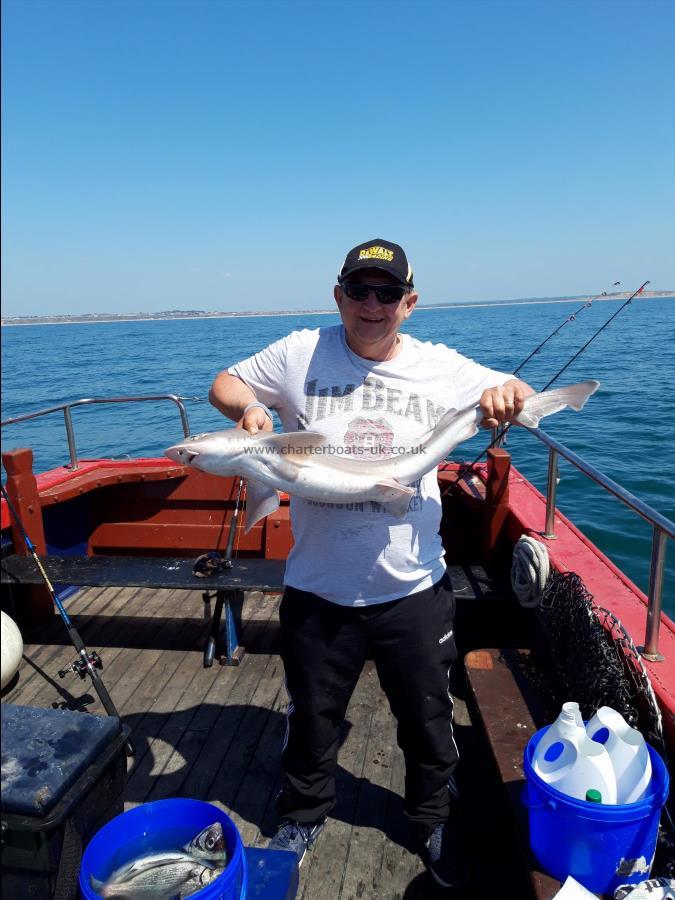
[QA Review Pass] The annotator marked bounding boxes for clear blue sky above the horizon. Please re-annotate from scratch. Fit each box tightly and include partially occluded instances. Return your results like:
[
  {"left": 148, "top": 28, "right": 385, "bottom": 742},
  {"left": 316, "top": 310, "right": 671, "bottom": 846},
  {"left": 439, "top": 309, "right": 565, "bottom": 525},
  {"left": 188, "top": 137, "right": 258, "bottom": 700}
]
[{"left": 2, "top": 0, "right": 675, "bottom": 316}]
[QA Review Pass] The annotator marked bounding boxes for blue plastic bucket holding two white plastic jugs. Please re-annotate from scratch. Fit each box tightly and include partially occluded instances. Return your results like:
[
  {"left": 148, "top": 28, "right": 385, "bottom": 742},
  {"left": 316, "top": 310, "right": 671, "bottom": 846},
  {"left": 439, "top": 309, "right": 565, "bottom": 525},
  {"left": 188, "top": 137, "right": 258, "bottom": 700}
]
[{"left": 523, "top": 728, "right": 668, "bottom": 895}]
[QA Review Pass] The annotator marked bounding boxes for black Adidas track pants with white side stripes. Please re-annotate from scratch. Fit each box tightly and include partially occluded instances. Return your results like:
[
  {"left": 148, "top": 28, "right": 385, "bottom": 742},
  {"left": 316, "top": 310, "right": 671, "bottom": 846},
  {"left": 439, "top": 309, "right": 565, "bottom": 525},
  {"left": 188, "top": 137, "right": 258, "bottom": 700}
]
[{"left": 277, "top": 575, "right": 458, "bottom": 834}]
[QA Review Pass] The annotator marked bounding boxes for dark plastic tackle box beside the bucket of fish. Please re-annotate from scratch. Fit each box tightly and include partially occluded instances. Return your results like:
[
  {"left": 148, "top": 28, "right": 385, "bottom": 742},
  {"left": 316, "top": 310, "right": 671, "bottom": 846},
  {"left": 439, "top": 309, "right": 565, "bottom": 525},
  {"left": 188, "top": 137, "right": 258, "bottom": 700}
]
[{"left": 0, "top": 704, "right": 129, "bottom": 900}]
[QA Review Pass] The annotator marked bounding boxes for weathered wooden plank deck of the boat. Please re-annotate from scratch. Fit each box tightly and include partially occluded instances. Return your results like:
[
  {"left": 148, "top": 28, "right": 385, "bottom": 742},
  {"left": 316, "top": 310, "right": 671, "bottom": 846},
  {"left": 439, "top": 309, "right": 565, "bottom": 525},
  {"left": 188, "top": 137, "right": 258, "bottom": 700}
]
[{"left": 3, "top": 577, "right": 529, "bottom": 900}]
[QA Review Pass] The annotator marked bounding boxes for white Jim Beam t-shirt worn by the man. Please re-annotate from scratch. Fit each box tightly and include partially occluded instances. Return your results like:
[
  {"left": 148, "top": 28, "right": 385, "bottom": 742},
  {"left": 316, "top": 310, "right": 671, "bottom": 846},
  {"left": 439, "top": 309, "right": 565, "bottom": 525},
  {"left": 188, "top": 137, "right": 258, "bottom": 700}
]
[{"left": 228, "top": 325, "right": 513, "bottom": 606}]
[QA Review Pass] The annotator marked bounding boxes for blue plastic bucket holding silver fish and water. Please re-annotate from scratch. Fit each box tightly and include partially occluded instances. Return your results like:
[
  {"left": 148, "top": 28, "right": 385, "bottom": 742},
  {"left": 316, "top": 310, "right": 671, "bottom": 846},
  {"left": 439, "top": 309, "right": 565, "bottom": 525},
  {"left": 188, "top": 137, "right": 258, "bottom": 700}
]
[{"left": 80, "top": 799, "right": 247, "bottom": 900}]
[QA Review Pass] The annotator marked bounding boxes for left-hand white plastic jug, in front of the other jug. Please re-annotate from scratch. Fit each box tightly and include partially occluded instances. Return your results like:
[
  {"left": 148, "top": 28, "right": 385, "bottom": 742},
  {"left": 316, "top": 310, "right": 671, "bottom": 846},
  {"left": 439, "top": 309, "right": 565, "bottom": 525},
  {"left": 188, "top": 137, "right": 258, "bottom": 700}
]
[{"left": 532, "top": 702, "right": 616, "bottom": 803}]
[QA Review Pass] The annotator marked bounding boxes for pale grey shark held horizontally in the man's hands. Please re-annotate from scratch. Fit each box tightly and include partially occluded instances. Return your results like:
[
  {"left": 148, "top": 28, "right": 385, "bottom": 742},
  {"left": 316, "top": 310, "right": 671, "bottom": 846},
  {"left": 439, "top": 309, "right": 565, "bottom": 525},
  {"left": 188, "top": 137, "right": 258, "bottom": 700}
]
[{"left": 165, "top": 381, "right": 600, "bottom": 532}]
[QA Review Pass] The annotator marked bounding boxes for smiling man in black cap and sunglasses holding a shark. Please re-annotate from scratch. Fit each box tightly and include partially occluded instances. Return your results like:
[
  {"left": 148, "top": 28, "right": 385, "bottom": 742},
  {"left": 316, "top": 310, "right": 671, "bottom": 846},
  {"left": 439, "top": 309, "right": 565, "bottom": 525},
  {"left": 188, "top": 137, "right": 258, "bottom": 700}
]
[{"left": 210, "top": 239, "right": 532, "bottom": 886}]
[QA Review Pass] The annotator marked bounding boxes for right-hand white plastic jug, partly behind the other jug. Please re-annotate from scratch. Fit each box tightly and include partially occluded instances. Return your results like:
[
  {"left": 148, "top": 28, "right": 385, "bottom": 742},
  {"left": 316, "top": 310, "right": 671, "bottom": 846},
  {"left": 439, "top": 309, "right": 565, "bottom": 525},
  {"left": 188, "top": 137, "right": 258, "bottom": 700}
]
[{"left": 586, "top": 706, "right": 652, "bottom": 803}]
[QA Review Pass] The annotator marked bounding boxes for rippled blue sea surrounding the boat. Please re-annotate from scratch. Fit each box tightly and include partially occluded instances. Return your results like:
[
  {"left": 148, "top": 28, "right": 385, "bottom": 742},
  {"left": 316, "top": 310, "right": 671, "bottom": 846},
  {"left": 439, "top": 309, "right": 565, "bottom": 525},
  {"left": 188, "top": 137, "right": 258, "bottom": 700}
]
[{"left": 2, "top": 297, "right": 675, "bottom": 618}]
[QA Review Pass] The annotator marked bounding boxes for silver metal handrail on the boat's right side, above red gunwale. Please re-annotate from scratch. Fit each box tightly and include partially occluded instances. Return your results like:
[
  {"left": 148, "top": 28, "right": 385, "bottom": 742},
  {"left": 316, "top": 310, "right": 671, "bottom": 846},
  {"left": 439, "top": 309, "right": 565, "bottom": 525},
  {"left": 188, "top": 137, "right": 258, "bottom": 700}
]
[{"left": 527, "top": 428, "right": 675, "bottom": 662}]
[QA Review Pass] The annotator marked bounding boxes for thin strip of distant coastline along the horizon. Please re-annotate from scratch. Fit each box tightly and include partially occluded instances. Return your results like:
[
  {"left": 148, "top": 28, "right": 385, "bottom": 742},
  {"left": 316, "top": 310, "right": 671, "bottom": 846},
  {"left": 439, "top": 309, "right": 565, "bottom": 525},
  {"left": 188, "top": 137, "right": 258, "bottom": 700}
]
[{"left": 0, "top": 291, "right": 675, "bottom": 327}]
